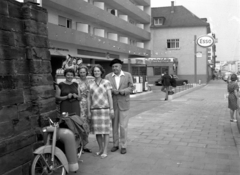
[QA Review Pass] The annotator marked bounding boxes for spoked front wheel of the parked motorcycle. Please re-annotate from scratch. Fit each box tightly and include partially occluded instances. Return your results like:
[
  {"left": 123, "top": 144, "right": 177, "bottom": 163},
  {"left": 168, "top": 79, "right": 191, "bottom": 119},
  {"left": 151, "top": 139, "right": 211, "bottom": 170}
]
[{"left": 31, "top": 153, "right": 66, "bottom": 175}]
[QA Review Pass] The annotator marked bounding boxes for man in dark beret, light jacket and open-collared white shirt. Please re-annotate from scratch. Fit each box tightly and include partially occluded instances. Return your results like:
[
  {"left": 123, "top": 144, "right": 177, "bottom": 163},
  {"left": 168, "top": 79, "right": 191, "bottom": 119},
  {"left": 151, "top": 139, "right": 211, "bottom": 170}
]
[{"left": 106, "top": 59, "right": 133, "bottom": 154}]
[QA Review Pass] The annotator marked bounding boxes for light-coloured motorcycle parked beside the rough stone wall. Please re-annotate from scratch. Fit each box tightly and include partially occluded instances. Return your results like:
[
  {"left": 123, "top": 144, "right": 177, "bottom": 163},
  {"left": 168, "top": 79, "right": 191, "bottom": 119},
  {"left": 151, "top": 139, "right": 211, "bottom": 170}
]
[{"left": 31, "top": 113, "right": 83, "bottom": 175}]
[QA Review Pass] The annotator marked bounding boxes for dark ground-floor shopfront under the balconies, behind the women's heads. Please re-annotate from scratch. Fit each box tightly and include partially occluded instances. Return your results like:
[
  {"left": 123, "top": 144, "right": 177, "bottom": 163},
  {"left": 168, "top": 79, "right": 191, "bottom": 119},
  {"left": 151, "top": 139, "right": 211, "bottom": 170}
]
[{"left": 49, "top": 41, "right": 120, "bottom": 82}]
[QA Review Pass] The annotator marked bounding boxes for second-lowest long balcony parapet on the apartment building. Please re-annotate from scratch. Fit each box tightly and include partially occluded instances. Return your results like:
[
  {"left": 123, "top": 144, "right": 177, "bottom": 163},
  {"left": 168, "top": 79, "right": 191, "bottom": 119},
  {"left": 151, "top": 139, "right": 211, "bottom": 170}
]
[{"left": 43, "top": 0, "right": 150, "bottom": 41}]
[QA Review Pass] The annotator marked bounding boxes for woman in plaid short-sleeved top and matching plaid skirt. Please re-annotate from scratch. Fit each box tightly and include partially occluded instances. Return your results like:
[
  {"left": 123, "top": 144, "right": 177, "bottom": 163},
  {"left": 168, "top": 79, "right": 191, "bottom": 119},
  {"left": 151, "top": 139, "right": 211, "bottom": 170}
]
[{"left": 88, "top": 65, "right": 114, "bottom": 158}]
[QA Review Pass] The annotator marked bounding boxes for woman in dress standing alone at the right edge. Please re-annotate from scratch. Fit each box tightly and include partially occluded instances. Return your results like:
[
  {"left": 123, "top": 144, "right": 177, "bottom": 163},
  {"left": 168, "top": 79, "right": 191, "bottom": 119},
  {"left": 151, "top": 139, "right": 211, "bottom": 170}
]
[{"left": 228, "top": 74, "right": 239, "bottom": 122}]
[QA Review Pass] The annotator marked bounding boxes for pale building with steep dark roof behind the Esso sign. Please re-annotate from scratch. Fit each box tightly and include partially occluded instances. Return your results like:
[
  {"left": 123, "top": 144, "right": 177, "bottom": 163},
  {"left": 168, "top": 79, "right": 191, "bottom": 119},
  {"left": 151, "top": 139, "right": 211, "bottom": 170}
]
[{"left": 147, "top": 2, "right": 212, "bottom": 83}]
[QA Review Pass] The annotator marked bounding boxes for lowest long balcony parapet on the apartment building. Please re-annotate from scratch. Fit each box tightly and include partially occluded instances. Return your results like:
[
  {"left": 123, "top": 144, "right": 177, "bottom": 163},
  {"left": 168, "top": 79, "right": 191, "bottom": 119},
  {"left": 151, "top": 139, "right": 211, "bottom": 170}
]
[{"left": 48, "top": 23, "right": 150, "bottom": 56}]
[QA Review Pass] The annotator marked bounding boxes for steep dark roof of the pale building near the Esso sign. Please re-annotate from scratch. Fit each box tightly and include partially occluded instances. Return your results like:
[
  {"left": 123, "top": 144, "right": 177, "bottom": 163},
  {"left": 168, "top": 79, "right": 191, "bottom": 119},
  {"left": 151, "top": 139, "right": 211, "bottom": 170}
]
[{"left": 152, "top": 6, "right": 210, "bottom": 32}]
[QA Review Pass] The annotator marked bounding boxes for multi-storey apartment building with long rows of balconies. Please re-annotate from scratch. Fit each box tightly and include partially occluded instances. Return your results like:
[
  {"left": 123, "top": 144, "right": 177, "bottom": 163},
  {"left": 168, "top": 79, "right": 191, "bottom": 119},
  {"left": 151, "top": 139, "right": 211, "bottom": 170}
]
[{"left": 42, "top": 0, "right": 151, "bottom": 78}]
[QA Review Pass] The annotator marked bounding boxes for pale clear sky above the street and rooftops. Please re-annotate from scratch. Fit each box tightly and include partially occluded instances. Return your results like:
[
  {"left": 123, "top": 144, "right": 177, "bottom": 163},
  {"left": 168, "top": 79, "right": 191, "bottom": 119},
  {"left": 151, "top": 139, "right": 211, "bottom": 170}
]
[{"left": 151, "top": 0, "right": 240, "bottom": 61}]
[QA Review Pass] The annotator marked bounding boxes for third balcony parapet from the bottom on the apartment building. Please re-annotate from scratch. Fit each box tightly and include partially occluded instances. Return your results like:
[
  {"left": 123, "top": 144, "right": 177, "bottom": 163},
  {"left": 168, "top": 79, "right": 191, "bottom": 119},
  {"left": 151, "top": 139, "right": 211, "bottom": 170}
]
[{"left": 94, "top": 0, "right": 150, "bottom": 24}]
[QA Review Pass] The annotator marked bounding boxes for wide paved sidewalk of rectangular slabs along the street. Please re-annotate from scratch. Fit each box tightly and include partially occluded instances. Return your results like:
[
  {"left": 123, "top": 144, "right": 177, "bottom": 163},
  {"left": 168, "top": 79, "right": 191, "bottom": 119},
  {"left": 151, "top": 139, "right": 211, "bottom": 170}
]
[{"left": 73, "top": 80, "right": 240, "bottom": 175}]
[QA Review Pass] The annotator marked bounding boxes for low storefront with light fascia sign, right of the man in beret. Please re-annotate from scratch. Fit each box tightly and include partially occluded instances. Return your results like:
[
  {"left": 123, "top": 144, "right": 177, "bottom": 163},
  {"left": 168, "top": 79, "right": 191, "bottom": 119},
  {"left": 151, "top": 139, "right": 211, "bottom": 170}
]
[{"left": 146, "top": 57, "right": 178, "bottom": 84}]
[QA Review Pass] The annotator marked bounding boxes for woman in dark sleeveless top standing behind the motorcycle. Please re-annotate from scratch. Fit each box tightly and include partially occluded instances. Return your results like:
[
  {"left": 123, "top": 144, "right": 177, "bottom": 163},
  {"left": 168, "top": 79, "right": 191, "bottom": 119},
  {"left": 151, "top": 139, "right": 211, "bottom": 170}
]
[{"left": 56, "top": 69, "right": 81, "bottom": 116}]
